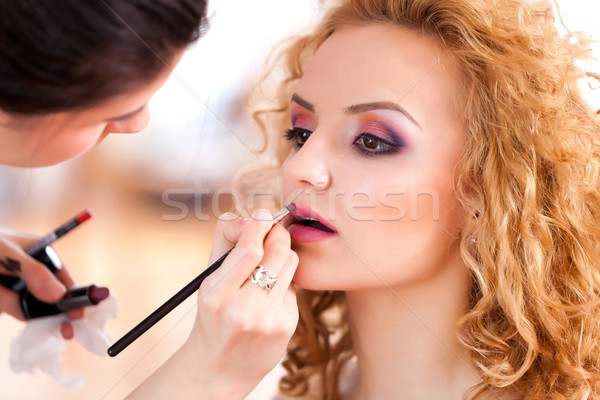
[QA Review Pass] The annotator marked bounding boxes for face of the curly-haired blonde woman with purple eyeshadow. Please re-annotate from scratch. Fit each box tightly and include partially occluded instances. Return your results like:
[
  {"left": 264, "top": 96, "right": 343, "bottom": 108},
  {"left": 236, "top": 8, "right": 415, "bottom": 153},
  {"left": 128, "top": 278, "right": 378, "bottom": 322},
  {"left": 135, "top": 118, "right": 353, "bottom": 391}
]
[{"left": 282, "top": 24, "right": 466, "bottom": 290}]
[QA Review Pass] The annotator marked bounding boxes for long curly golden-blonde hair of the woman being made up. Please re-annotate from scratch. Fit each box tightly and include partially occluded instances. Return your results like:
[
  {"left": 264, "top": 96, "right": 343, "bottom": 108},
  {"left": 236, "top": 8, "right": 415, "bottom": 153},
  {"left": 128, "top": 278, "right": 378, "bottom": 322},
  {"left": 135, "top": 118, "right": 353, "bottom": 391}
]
[{"left": 255, "top": 0, "right": 600, "bottom": 399}]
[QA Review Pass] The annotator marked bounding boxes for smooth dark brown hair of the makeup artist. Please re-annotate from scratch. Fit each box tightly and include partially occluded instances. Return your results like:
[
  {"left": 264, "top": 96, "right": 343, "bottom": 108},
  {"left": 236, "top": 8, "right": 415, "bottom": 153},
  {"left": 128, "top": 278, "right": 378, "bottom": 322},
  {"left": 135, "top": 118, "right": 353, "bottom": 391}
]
[{"left": 0, "top": 0, "right": 206, "bottom": 116}]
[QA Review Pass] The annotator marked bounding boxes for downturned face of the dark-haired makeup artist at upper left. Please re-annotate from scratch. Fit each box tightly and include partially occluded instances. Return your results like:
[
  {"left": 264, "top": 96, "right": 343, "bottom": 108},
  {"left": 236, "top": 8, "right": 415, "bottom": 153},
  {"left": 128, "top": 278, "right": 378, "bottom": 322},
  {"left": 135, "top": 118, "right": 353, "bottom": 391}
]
[{"left": 0, "top": 55, "right": 180, "bottom": 167}]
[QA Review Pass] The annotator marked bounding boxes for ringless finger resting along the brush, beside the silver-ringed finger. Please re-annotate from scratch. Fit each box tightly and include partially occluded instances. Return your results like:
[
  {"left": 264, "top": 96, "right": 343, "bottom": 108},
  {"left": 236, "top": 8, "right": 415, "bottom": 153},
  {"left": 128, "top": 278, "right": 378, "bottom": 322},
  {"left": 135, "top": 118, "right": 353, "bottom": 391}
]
[{"left": 202, "top": 210, "right": 272, "bottom": 291}]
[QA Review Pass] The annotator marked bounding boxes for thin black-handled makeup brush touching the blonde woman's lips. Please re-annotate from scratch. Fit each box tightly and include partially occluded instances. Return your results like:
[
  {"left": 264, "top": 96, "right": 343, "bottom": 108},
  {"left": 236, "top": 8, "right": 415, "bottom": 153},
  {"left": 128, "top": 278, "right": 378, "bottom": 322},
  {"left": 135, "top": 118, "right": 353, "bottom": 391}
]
[{"left": 108, "top": 203, "right": 296, "bottom": 357}]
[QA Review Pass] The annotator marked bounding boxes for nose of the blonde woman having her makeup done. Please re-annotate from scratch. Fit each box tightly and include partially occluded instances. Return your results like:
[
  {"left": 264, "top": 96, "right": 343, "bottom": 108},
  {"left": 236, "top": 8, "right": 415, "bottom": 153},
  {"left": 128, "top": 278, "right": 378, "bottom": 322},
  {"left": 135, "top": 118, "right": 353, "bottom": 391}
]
[{"left": 282, "top": 133, "right": 332, "bottom": 190}]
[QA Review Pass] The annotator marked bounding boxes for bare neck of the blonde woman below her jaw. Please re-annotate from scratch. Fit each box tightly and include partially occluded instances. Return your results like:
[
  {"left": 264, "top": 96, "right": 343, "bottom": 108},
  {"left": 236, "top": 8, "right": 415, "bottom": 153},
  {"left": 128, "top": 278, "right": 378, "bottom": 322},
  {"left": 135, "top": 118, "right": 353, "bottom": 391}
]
[{"left": 346, "top": 253, "right": 479, "bottom": 400}]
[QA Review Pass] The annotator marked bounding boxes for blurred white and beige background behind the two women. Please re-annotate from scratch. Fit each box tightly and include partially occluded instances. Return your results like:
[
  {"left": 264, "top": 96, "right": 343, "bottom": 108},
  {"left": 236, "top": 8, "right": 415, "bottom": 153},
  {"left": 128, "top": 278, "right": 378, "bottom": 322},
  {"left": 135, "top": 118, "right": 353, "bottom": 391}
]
[{"left": 0, "top": 0, "right": 600, "bottom": 399}]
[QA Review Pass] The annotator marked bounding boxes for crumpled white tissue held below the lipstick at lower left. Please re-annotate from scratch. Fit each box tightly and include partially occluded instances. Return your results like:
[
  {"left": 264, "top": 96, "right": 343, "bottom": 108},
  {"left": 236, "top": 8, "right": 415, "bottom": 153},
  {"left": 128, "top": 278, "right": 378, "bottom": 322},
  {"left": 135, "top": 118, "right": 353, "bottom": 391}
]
[{"left": 10, "top": 294, "right": 118, "bottom": 390}]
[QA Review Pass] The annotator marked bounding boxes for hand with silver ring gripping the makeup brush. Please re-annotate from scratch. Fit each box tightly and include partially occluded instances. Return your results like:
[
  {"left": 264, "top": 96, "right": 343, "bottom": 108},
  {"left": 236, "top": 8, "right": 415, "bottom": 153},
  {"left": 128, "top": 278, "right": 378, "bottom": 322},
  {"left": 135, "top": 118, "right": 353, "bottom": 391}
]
[{"left": 132, "top": 210, "right": 298, "bottom": 398}]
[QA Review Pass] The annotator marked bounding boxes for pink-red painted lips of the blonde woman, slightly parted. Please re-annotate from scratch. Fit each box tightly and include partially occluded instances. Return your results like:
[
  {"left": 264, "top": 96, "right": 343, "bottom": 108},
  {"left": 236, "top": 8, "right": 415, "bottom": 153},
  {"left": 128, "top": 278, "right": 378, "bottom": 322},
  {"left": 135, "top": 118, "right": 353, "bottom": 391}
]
[{"left": 288, "top": 205, "right": 337, "bottom": 242}]
